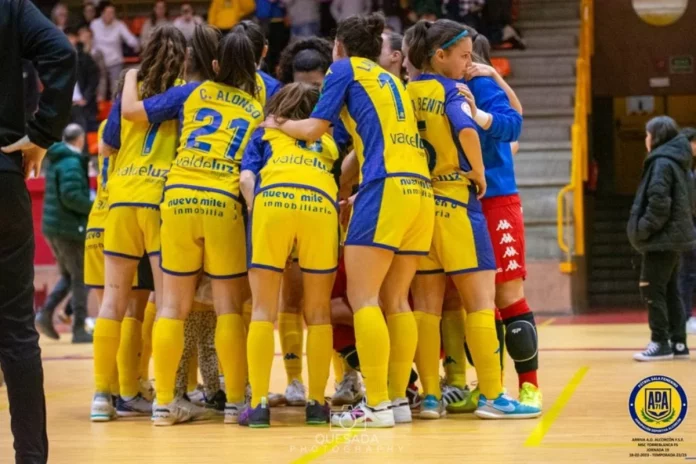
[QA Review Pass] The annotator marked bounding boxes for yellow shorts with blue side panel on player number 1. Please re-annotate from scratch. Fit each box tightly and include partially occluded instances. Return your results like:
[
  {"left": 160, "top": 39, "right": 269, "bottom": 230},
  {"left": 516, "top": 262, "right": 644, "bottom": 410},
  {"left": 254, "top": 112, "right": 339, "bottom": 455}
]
[{"left": 345, "top": 176, "right": 435, "bottom": 255}]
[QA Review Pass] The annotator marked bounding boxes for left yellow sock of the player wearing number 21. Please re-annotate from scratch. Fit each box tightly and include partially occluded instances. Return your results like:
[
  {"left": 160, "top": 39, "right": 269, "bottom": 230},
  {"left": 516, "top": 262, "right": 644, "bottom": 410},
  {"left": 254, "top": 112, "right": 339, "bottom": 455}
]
[{"left": 152, "top": 317, "right": 184, "bottom": 405}]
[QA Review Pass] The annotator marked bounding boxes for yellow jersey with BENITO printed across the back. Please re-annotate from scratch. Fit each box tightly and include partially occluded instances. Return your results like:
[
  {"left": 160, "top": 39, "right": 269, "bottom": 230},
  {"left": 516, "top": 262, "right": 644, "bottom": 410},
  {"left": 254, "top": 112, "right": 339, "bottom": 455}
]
[{"left": 407, "top": 74, "right": 477, "bottom": 204}]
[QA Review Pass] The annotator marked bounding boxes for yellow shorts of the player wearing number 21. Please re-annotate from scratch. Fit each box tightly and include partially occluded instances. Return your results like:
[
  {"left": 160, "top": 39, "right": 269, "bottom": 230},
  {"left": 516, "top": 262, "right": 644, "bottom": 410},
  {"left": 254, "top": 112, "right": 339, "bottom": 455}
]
[{"left": 161, "top": 187, "right": 247, "bottom": 279}]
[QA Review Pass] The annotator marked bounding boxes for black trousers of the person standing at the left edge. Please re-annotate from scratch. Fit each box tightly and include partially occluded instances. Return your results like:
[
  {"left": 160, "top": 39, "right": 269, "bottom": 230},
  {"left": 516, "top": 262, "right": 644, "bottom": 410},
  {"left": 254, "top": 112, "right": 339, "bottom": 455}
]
[{"left": 0, "top": 172, "right": 48, "bottom": 464}]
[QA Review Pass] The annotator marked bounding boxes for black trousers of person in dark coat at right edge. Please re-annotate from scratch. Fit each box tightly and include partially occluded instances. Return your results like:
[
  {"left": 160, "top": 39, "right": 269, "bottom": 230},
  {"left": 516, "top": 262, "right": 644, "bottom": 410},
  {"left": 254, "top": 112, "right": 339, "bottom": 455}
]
[{"left": 640, "top": 251, "right": 686, "bottom": 343}]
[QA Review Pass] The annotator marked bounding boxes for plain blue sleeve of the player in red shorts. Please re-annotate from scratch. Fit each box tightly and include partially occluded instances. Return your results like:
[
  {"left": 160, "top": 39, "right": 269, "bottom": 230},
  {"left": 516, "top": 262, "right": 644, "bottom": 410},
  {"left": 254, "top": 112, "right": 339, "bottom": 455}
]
[{"left": 469, "top": 77, "right": 522, "bottom": 143}]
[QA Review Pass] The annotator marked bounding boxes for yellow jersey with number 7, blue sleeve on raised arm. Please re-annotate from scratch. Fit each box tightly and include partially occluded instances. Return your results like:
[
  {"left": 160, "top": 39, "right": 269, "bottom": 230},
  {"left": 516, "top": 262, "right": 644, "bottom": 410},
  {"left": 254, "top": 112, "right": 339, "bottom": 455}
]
[{"left": 104, "top": 81, "right": 183, "bottom": 207}]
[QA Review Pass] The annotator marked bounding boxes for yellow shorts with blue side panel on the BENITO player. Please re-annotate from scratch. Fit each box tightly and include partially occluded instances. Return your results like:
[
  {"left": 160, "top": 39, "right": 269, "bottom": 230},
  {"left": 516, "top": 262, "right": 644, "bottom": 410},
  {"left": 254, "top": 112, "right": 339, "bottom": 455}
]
[{"left": 418, "top": 184, "right": 496, "bottom": 275}]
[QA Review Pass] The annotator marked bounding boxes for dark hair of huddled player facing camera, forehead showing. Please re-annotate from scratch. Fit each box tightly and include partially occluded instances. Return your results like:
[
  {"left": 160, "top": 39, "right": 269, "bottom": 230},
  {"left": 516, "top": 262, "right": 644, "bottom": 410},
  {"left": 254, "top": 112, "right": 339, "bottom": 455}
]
[{"left": 278, "top": 37, "right": 332, "bottom": 84}]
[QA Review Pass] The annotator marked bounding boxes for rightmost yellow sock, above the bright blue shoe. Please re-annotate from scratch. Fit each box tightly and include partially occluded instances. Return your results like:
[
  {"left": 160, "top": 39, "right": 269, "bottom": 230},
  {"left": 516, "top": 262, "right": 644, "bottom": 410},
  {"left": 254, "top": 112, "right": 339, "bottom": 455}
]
[{"left": 466, "top": 309, "right": 503, "bottom": 399}]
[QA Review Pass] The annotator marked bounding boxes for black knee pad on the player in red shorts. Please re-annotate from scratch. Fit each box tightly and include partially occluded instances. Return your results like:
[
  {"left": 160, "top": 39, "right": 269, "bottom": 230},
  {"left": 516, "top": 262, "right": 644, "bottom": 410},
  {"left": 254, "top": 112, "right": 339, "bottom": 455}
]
[{"left": 505, "top": 313, "right": 539, "bottom": 373}]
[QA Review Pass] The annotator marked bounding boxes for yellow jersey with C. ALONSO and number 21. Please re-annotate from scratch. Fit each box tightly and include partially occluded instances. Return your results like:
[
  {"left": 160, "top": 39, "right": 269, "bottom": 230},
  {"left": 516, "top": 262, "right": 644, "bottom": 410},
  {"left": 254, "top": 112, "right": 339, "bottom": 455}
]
[{"left": 144, "top": 81, "right": 264, "bottom": 199}]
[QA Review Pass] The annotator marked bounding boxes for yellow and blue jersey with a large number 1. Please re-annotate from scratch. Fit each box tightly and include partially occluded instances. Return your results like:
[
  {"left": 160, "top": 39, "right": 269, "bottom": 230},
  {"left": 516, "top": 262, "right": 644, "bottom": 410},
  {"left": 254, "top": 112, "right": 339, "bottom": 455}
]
[{"left": 312, "top": 57, "right": 430, "bottom": 185}]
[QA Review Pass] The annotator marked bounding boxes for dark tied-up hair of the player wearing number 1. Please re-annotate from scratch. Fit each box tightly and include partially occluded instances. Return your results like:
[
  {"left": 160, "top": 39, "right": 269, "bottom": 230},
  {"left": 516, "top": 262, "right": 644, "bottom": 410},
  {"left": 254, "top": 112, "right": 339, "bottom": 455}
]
[{"left": 336, "top": 13, "right": 384, "bottom": 61}]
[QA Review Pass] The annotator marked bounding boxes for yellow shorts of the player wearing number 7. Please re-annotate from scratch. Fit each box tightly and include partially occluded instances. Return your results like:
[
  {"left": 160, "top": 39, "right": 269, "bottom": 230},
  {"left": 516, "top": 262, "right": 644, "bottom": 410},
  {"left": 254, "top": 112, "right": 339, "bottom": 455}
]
[{"left": 104, "top": 206, "right": 160, "bottom": 259}]
